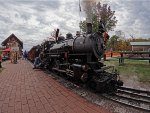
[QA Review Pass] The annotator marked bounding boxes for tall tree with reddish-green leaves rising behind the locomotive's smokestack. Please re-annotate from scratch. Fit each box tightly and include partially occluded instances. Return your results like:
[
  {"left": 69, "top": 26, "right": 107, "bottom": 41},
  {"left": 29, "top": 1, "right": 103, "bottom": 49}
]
[{"left": 79, "top": 2, "right": 117, "bottom": 32}]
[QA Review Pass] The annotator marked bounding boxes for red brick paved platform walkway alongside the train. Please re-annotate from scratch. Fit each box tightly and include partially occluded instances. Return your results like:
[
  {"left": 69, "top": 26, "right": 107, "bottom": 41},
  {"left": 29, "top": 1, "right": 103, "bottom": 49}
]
[{"left": 0, "top": 60, "right": 108, "bottom": 113}]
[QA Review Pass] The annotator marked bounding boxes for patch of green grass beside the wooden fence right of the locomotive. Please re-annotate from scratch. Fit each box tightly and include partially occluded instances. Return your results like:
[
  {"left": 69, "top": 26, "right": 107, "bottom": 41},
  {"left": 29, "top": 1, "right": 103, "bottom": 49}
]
[{"left": 104, "top": 58, "right": 150, "bottom": 82}]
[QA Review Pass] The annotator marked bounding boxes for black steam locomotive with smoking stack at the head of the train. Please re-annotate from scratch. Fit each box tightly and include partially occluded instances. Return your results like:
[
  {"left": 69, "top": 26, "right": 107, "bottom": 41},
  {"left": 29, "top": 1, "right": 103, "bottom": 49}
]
[{"left": 40, "top": 23, "right": 123, "bottom": 93}]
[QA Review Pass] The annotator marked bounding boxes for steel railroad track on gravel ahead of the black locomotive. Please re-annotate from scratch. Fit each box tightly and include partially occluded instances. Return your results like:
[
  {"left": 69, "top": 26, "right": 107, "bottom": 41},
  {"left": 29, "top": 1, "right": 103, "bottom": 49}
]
[{"left": 102, "top": 87, "right": 150, "bottom": 112}]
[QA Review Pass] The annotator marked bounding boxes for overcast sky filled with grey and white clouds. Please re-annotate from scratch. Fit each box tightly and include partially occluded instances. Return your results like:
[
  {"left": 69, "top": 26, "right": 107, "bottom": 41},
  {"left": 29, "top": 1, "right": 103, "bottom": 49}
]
[{"left": 0, "top": 0, "right": 150, "bottom": 50}]
